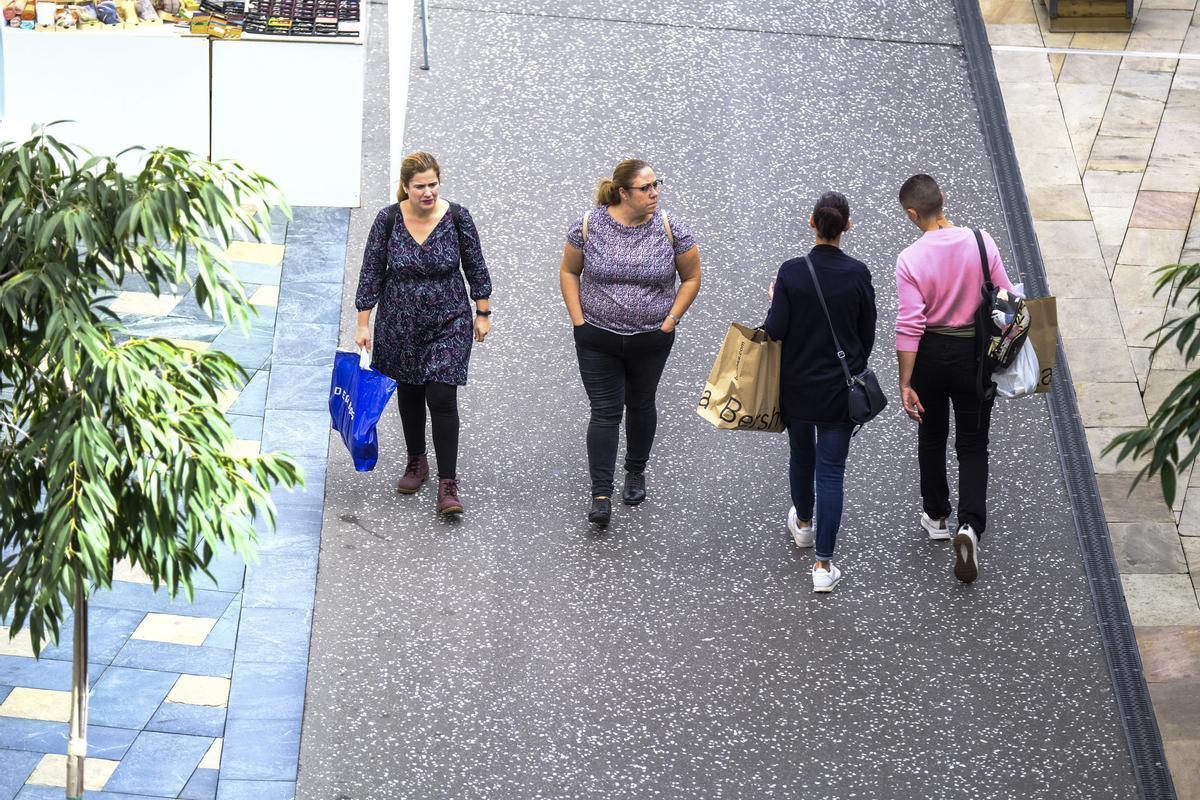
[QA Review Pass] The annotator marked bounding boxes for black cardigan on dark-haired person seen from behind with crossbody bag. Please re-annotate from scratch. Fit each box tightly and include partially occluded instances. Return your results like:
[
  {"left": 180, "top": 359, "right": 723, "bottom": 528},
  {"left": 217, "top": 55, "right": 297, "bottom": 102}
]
[{"left": 763, "top": 245, "right": 876, "bottom": 425}]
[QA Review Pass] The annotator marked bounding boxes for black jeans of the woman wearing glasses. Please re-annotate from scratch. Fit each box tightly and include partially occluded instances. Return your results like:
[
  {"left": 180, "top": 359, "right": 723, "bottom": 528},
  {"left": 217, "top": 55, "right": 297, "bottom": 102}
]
[{"left": 575, "top": 323, "right": 674, "bottom": 497}]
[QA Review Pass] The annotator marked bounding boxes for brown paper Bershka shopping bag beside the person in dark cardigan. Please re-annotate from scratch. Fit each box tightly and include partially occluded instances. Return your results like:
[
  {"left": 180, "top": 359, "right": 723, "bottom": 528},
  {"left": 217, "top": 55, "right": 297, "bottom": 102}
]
[{"left": 696, "top": 323, "right": 784, "bottom": 433}]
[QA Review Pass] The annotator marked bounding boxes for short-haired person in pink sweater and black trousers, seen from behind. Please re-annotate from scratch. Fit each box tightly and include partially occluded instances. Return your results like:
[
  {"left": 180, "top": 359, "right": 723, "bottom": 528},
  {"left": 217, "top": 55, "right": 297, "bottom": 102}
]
[{"left": 896, "top": 175, "right": 1013, "bottom": 583}]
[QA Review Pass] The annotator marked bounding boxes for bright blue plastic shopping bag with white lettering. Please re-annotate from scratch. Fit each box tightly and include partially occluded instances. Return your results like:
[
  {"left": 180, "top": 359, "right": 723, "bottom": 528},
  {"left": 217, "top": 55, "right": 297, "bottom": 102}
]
[{"left": 329, "top": 350, "right": 396, "bottom": 473}]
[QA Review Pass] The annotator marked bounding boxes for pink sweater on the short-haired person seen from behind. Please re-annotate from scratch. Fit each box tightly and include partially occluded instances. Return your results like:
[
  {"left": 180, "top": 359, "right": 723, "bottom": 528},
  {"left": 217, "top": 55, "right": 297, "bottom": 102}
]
[{"left": 896, "top": 228, "right": 1013, "bottom": 351}]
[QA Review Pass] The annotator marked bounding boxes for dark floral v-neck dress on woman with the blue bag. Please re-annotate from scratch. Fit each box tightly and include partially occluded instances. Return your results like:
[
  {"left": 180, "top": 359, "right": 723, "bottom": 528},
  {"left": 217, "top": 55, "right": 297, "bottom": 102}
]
[{"left": 354, "top": 203, "right": 492, "bottom": 386}]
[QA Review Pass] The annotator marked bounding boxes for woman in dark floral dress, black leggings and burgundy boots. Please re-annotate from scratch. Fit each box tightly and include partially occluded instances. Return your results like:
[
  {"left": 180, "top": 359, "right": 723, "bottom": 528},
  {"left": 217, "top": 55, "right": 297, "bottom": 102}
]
[{"left": 354, "top": 152, "right": 492, "bottom": 515}]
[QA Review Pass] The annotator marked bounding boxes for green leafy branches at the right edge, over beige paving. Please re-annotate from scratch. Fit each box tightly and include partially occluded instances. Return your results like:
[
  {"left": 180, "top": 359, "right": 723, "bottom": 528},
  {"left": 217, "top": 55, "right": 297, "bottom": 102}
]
[{"left": 1104, "top": 264, "right": 1200, "bottom": 506}]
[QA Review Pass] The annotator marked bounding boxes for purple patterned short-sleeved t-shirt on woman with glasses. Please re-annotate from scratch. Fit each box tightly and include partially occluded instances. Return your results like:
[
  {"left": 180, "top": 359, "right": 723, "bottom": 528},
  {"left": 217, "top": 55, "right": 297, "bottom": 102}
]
[{"left": 566, "top": 205, "right": 696, "bottom": 335}]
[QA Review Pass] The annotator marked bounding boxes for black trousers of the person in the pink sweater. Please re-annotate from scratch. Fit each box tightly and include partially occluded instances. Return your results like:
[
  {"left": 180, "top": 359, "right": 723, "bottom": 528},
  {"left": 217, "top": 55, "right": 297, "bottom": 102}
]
[{"left": 912, "top": 331, "right": 992, "bottom": 536}]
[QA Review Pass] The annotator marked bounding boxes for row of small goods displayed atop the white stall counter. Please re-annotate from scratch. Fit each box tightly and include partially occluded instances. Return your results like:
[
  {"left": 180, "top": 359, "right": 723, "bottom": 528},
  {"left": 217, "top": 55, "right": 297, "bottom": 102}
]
[{"left": 0, "top": 0, "right": 361, "bottom": 38}]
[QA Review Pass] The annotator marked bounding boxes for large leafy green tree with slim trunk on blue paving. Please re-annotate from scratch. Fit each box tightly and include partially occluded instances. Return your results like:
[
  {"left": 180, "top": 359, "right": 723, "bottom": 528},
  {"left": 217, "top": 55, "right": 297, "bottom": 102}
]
[{"left": 0, "top": 128, "right": 301, "bottom": 799}]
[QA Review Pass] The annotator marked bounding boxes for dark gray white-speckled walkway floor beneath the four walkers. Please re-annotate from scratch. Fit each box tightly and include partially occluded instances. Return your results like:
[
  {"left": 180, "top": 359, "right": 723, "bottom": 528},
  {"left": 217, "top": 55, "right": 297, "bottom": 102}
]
[{"left": 299, "top": 0, "right": 1136, "bottom": 800}]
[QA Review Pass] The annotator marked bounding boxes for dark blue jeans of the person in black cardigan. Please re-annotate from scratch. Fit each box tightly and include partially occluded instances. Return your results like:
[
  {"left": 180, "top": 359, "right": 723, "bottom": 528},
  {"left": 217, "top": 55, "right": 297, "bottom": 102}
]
[{"left": 787, "top": 422, "right": 854, "bottom": 561}]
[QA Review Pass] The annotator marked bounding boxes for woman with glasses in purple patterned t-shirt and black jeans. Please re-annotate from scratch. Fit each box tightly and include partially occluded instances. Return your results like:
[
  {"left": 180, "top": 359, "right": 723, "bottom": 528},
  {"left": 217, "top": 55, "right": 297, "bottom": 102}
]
[{"left": 559, "top": 158, "right": 700, "bottom": 527}]
